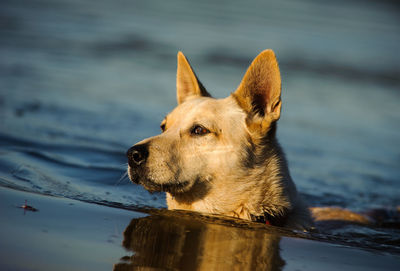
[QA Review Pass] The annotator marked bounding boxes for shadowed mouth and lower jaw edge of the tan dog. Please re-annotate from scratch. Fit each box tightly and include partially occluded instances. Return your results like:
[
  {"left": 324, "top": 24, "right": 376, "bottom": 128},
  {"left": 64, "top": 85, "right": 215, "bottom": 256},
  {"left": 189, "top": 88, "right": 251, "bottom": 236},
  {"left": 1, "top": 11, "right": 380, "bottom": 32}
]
[{"left": 128, "top": 167, "right": 191, "bottom": 194}]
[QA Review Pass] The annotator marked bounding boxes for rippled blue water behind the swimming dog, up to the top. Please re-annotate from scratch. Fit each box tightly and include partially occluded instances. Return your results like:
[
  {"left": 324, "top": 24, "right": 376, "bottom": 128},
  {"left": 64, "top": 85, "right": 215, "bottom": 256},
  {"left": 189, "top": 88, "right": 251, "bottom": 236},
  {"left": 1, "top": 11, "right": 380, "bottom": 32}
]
[{"left": 0, "top": 0, "right": 400, "bottom": 255}]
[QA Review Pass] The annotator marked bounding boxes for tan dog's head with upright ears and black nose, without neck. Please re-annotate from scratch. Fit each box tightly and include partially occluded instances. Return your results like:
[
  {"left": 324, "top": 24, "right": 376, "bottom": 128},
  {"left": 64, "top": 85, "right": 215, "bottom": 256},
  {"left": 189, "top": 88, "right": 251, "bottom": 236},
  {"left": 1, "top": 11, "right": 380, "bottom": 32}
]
[{"left": 127, "top": 50, "right": 281, "bottom": 199}]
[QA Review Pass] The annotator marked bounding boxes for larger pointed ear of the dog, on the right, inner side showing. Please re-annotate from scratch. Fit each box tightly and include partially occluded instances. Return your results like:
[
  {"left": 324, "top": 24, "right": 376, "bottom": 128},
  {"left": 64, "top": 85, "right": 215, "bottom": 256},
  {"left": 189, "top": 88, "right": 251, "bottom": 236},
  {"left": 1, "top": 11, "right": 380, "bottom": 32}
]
[{"left": 232, "top": 50, "right": 281, "bottom": 126}]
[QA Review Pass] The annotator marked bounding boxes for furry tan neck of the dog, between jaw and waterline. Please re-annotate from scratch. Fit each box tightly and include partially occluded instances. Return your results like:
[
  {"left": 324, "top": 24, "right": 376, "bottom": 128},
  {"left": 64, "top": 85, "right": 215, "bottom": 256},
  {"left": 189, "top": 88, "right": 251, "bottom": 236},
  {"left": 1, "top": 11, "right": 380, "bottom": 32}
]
[{"left": 167, "top": 142, "right": 296, "bottom": 223}]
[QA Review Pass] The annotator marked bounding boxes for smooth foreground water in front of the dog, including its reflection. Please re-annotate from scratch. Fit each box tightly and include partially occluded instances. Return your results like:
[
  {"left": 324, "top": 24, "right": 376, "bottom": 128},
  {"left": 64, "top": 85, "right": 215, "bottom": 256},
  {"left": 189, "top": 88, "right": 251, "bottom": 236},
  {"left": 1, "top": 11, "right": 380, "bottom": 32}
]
[{"left": 0, "top": 187, "right": 400, "bottom": 271}]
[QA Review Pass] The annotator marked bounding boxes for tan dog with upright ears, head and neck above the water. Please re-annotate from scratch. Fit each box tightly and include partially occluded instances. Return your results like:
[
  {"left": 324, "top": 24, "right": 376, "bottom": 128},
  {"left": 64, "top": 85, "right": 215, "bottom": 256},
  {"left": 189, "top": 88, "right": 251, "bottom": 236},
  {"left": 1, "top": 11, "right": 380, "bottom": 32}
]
[{"left": 127, "top": 50, "right": 313, "bottom": 230}]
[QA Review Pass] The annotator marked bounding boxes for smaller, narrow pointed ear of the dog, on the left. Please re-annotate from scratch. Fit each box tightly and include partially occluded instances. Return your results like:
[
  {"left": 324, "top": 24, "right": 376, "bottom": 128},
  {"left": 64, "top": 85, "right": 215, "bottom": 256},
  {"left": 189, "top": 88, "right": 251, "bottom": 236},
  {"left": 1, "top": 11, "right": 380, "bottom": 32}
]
[{"left": 176, "top": 52, "right": 211, "bottom": 104}]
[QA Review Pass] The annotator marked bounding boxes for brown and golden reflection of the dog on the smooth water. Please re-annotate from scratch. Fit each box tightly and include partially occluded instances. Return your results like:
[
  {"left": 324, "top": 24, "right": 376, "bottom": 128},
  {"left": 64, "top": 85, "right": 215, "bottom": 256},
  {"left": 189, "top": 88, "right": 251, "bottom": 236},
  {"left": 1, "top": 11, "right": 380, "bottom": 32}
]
[{"left": 114, "top": 215, "right": 284, "bottom": 271}]
